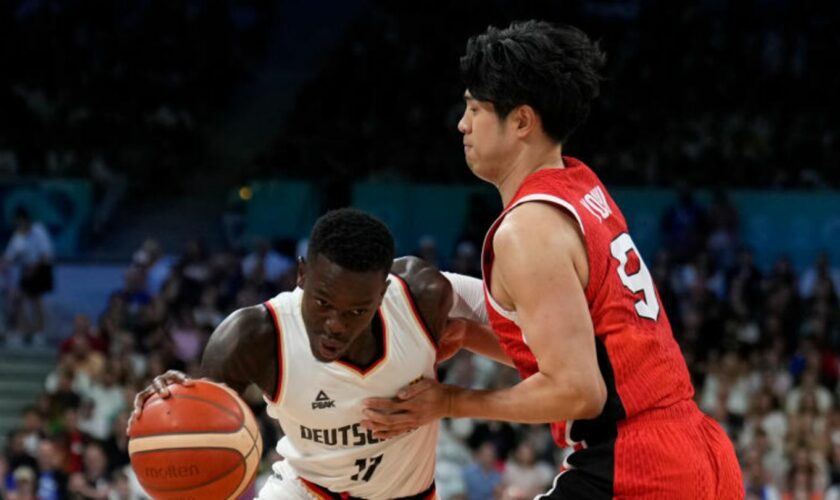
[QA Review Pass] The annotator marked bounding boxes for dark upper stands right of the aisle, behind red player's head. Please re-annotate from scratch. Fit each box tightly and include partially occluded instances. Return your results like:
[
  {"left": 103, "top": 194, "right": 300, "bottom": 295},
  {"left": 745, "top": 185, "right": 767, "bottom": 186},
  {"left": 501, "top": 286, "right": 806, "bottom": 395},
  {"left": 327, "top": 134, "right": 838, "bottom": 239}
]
[{"left": 261, "top": 0, "right": 840, "bottom": 190}]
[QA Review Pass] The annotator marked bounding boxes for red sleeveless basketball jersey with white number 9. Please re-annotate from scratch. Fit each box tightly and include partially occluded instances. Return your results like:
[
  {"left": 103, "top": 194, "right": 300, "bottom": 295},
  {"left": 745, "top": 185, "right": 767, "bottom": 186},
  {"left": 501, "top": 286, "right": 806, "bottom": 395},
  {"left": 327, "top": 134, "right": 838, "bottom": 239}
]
[{"left": 482, "top": 157, "right": 694, "bottom": 446}]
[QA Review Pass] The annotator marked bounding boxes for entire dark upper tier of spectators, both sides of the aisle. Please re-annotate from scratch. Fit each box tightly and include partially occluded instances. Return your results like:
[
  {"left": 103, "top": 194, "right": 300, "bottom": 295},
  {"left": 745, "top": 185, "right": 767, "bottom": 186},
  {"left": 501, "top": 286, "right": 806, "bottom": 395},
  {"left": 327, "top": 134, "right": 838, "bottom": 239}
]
[{"left": 0, "top": 0, "right": 840, "bottom": 195}]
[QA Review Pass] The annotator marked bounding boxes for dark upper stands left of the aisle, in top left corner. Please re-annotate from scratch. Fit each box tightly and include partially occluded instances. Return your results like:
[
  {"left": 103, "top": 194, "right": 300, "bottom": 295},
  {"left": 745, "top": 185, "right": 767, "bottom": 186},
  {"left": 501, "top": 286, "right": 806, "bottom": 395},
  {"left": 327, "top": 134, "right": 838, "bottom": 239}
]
[{"left": 0, "top": 0, "right": 274, "bottom": 192}]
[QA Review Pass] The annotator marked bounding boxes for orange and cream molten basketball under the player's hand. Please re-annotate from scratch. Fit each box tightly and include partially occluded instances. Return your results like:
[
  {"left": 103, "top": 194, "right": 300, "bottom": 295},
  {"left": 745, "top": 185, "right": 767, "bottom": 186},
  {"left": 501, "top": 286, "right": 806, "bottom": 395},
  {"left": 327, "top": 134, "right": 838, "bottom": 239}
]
[{"left": 128, "top": 380, "right": 262, "bottom": 500}]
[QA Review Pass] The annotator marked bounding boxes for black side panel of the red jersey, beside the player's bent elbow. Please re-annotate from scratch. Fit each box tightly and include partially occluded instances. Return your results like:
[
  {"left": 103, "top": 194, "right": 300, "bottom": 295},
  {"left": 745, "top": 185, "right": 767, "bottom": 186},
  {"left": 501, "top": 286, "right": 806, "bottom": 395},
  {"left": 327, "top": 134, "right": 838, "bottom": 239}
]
[{"left": 569, "top": 337, "right": 627, "bottom": 446}]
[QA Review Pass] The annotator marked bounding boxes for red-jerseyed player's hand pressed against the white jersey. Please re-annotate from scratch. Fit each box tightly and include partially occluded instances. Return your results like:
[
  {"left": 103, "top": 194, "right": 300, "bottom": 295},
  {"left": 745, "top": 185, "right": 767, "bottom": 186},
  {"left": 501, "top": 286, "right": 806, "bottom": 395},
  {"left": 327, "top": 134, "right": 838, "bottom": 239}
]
[{"left": 361, "top": 379, "right": 455, "bottom": 439}]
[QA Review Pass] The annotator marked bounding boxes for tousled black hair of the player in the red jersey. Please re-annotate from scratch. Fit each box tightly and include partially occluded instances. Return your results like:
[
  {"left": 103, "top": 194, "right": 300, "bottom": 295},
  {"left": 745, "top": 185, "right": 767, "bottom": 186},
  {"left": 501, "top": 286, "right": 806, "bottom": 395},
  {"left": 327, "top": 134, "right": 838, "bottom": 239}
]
[{"left": 461, "top": 20, "right": 606, "bottom": 143}]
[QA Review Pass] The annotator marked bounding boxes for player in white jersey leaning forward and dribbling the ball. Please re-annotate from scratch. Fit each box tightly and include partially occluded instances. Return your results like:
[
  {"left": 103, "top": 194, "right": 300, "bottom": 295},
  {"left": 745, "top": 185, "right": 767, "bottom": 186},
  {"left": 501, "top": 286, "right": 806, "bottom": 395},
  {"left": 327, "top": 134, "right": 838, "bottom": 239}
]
[{"left": 133, "top": 209, "right": 512, "bottom": 500}]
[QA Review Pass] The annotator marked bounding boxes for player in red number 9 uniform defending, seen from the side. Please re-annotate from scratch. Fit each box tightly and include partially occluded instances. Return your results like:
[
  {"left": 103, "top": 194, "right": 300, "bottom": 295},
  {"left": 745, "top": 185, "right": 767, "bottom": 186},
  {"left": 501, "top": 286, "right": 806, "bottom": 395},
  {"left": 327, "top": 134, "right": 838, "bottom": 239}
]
[{"left": 363, "top": 21, "right": 744, "bottom": 499}]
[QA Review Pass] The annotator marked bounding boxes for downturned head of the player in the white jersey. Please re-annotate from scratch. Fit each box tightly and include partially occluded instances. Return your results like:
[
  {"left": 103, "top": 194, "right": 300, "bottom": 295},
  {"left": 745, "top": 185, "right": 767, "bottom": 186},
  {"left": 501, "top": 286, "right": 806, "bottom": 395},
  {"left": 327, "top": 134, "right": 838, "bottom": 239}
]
[{"left": 298, "top": 208, "right": 394, "bottom": 361}]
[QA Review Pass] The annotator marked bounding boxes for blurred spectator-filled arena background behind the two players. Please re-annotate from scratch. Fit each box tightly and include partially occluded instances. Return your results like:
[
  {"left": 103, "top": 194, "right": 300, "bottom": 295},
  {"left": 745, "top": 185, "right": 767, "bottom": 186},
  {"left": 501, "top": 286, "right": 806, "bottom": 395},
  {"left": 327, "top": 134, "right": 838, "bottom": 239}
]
[{"left": 0, "top": 0, "right": 840, "bottom": 500}]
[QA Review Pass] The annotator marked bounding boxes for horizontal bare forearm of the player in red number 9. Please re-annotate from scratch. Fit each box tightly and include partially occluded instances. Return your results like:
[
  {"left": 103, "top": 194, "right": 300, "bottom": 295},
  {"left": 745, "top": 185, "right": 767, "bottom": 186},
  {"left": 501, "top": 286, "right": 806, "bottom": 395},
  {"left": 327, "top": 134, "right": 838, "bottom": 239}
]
[{"left": 447, "top": 373, "right": 606, "bottom": 424}]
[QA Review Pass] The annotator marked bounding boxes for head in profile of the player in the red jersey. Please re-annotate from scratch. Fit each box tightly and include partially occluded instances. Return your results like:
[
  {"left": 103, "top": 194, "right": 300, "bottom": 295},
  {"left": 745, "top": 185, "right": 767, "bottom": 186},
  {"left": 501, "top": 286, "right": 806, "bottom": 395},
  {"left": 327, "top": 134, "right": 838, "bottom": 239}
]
[{"left": 458, "top": 20, "right": 605, "bottom": 178}]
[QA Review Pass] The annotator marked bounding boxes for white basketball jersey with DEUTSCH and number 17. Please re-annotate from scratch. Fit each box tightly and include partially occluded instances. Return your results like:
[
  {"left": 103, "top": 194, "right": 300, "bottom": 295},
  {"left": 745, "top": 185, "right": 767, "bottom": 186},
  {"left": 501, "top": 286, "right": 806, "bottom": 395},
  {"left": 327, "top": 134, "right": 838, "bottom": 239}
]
[{"left": 266, "top": 275, "right": 438, "bottom": 499}]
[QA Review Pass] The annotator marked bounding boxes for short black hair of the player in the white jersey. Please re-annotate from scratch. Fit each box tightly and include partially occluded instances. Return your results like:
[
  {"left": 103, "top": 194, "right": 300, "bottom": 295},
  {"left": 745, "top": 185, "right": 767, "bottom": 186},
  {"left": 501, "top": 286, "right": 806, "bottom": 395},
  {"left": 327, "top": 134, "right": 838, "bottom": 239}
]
[{"left": 306, "top": 208, "right": 395, "bottom": 274}]
